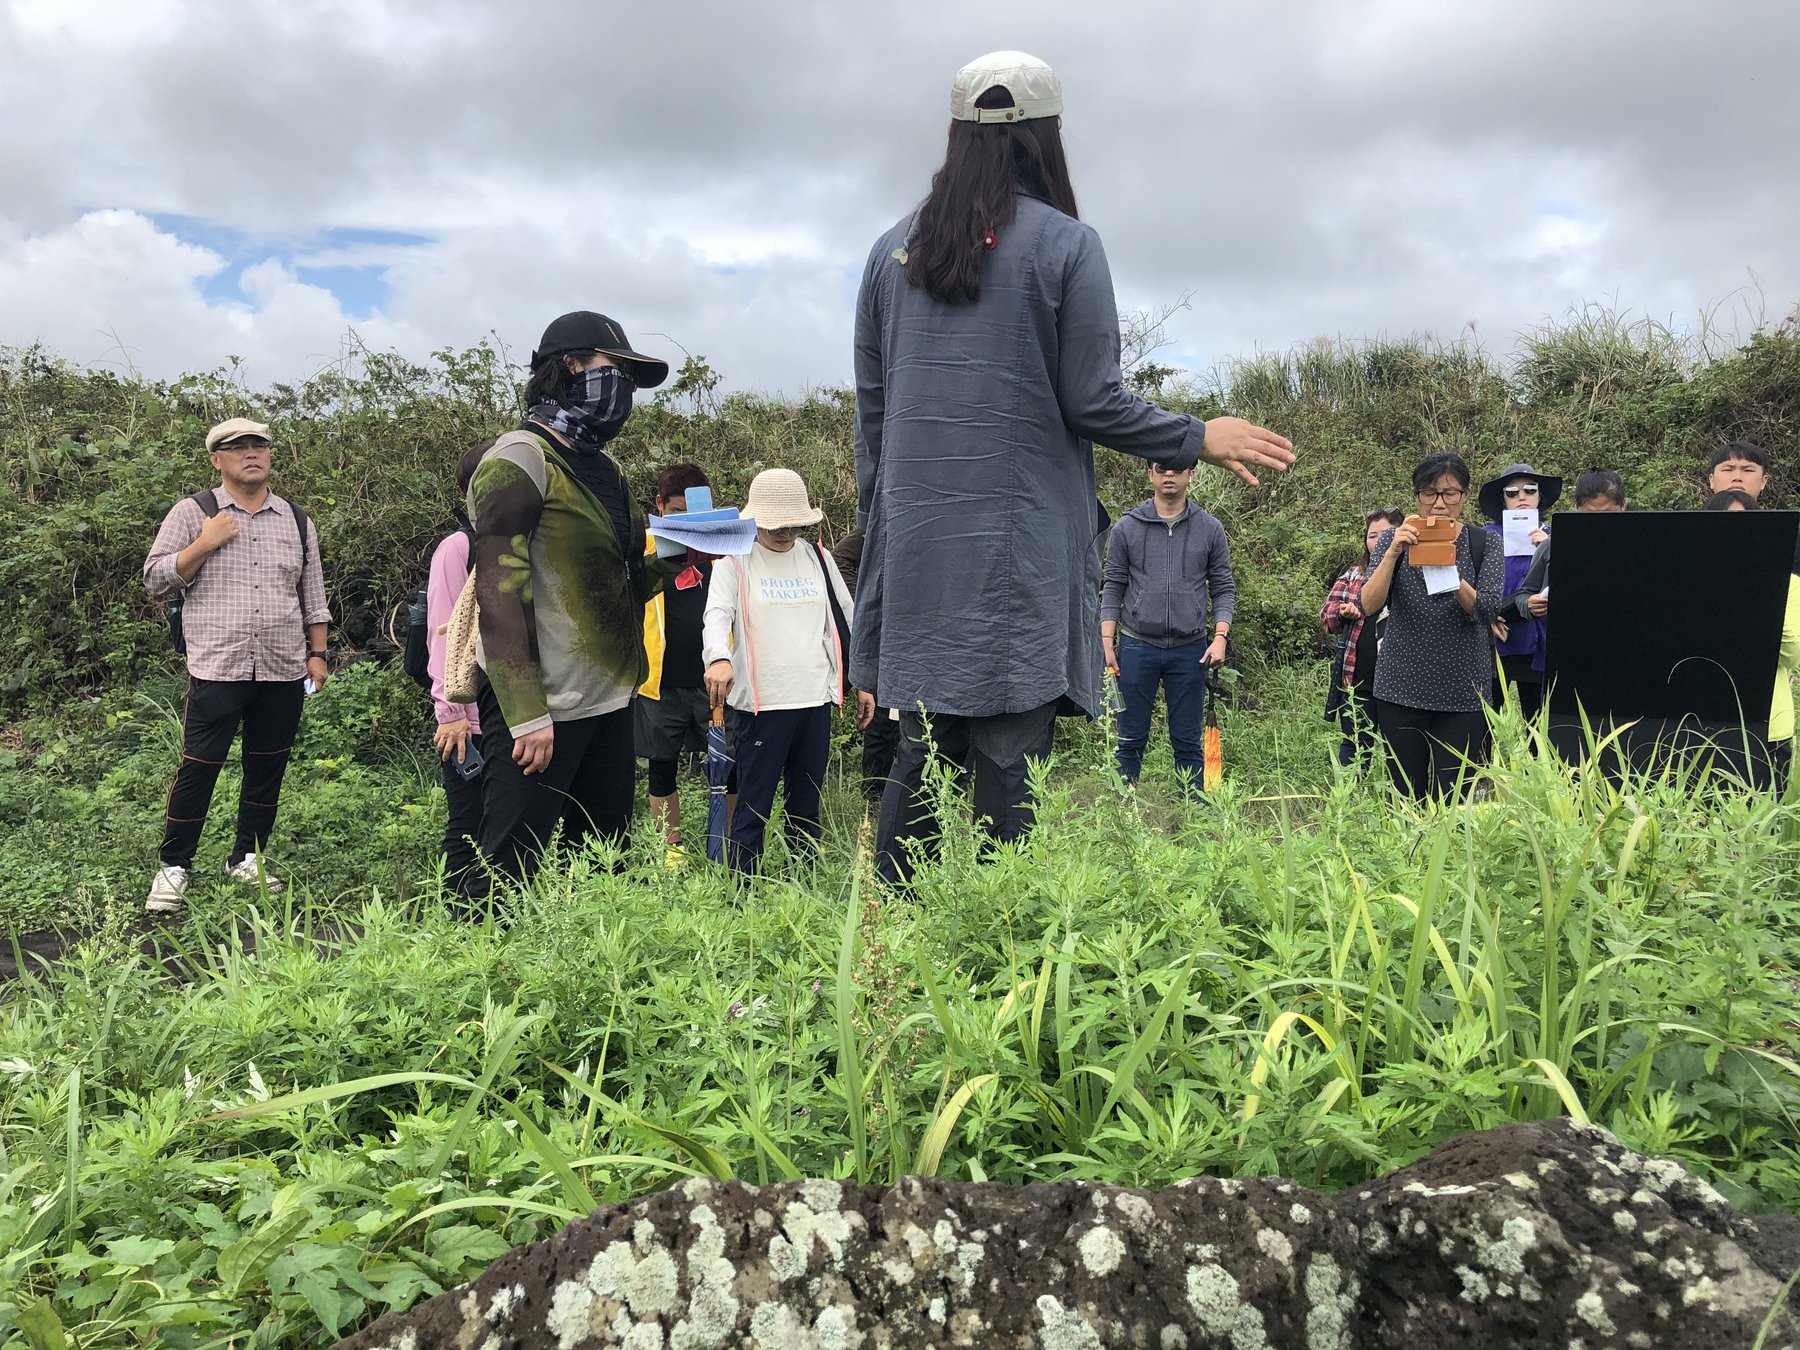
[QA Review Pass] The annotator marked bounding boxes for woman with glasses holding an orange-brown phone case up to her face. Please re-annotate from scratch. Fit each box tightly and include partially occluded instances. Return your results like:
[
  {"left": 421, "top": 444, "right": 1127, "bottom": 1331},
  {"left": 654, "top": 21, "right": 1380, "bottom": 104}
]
[{"left": 1357, "top": 452, "right": 1505, "bottom": 797}]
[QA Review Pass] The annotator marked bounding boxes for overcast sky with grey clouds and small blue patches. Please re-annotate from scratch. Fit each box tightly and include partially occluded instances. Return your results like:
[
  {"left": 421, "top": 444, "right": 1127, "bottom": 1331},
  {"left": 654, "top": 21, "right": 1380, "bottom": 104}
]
[{"left": 0, "top": 0, "right": 1800, "bottom": 394}]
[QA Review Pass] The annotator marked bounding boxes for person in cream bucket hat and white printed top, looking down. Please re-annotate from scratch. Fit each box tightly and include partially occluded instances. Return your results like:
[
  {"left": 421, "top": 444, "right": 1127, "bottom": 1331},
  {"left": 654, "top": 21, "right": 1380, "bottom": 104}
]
[{"left": 700, "top": 468, "right": 875, "bottom": 873}]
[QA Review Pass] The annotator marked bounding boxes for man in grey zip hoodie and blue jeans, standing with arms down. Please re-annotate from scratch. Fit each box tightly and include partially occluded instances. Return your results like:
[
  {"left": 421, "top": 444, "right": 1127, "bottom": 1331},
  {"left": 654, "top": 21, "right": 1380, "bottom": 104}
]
[{"left": 1100, "top": 463, "right": 1237, "bottom": 796}]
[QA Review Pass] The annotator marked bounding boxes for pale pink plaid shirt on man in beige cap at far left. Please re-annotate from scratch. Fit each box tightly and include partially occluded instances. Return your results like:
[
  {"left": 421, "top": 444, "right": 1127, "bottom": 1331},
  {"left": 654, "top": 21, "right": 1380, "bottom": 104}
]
[{"left": 144, "top": 488, "right": 331, "bottom": 680}]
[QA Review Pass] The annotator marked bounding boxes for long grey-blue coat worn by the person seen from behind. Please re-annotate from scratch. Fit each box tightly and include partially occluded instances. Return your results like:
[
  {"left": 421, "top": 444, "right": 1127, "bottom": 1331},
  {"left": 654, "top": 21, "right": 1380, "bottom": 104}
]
[{"left": 850, "top": 196, "right": 1204, "bottom": 716}]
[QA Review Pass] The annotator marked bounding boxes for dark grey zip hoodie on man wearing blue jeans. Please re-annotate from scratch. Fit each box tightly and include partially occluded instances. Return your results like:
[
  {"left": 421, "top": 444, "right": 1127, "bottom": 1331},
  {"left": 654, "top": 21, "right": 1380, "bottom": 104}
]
[{"left": 1100, "top": 499, "right": 1237, "bottom": 646}]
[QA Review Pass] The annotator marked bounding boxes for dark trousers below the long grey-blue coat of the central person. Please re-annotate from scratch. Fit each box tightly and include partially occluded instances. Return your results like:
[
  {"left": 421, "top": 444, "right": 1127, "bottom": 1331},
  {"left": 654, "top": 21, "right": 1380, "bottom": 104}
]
[{"left": 875, "top": 704, "right": 1057, "bottom": 882}]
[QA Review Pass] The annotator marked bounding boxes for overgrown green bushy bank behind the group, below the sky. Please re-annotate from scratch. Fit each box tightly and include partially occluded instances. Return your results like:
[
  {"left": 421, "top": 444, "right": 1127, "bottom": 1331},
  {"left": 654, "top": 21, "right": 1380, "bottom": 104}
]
[{"left": 0, "top": 310, "right": 1800, "bottom": 704}]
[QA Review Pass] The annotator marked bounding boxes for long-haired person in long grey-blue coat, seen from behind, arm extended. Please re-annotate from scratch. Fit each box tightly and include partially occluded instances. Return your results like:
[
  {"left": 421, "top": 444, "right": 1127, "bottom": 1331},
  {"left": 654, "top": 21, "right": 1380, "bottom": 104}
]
[{"left": 851, "top": 52, "right": 1292, "bottom": 878}]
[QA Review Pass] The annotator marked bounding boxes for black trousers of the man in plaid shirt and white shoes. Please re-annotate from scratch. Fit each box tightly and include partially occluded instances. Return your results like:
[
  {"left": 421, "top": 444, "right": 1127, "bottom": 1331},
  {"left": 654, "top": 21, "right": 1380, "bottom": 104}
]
[{"left": 162, "top": 675, "right": 306, "bottom": 868}]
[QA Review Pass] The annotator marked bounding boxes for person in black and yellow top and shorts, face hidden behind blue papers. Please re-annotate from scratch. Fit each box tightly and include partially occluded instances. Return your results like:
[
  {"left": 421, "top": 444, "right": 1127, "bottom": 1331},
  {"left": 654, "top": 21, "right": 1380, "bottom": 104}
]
[{"left": 635, "top": 464, "right": 713, "bottom": 866}]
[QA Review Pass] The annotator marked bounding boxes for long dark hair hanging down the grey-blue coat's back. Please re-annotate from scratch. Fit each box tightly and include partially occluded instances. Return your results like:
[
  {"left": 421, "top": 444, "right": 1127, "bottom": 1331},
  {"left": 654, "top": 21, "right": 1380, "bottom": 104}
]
[{"left": 904, "top": 85, "right": 1080, "bottom": 304}]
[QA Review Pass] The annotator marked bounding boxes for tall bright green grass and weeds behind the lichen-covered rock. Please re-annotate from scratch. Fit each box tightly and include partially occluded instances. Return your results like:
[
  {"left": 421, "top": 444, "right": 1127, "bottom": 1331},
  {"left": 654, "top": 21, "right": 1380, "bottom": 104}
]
[{"left": 0, "top": 680, "right": 1800, "bottom": 1346}]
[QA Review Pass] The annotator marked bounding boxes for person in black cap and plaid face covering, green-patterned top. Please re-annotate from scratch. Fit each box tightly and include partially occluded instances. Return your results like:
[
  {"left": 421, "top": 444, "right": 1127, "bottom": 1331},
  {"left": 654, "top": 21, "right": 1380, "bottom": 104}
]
[{"left": 463, "top": 310, "right": 677, "bottom": 914}]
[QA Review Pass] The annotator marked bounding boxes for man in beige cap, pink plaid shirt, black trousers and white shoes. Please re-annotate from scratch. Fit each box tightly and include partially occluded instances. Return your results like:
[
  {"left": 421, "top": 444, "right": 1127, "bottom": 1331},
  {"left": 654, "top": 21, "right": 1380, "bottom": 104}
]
[{"left": 144, "top": 418, "right": 331, "bottom": 913}]
